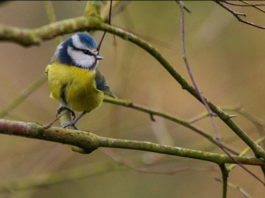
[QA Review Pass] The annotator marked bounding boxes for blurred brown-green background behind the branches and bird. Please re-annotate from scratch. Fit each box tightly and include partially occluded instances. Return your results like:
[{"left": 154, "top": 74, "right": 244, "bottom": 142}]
[{"left": 0, "top": 1, "right": 265, "bottom": 198}]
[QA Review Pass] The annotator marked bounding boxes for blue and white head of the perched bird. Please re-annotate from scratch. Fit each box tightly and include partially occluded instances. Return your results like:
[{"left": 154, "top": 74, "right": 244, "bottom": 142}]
[{"left": 55, "top": 33, "right": 103, "bottom": 70}]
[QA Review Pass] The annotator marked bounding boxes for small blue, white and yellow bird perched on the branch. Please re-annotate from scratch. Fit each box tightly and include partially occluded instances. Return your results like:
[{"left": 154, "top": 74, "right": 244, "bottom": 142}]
[{"left": 45, "top": 33, "right": 116, "bottom": 128}]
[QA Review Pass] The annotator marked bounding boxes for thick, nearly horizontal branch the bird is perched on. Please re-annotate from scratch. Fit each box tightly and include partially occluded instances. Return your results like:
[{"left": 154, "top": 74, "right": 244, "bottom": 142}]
[{"left": 0, "top": 120, "right": 265, "bottom": 166}]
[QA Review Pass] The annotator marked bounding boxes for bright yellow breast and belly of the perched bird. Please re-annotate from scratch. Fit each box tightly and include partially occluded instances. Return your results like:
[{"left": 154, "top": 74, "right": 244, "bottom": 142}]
[{"left": 46, "top": 63, "right": 104, "bottom": 112}]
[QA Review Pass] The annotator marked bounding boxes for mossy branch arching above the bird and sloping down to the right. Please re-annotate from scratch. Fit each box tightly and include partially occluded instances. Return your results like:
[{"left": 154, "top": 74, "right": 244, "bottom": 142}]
[{"left": 0, "top": 17, "right": 265, "bottom": 159}]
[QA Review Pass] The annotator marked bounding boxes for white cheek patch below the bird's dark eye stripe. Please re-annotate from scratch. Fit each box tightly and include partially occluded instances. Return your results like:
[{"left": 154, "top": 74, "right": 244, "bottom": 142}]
[{"left": 67, "top": 46, "right": 98, "bottom": 69}]
